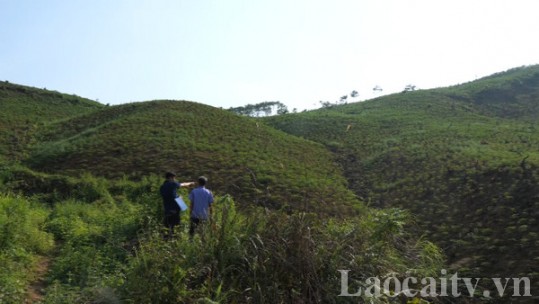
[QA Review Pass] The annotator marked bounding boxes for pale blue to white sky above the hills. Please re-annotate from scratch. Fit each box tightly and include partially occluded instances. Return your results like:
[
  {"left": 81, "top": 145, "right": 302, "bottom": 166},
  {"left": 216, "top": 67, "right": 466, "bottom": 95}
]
[{"left": 0, "top": 0, "right": 539, "bottom": 110}]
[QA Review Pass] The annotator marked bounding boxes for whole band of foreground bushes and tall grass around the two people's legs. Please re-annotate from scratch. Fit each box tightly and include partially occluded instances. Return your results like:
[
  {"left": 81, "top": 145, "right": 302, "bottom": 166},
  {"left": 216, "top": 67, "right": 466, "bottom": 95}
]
[{"left": 1, "top": 189, "right": 442, "bottom": 303}]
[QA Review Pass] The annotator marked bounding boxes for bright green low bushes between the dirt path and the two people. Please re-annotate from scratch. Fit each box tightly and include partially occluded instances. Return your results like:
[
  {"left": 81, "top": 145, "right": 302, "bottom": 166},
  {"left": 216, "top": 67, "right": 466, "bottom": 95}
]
[{"left": 45, "top": 201, "right": 145, "bottom": 303}]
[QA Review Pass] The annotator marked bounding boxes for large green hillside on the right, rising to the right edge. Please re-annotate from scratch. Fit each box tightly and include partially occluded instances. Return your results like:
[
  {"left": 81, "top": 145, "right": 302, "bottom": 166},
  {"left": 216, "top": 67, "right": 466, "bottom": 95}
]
[{"left": 266, "top": 66, "right": 539, "bottom": 288}]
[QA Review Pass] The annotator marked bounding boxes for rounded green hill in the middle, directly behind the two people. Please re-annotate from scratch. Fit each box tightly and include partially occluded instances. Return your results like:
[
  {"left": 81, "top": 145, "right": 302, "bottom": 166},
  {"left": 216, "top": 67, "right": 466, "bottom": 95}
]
[{"left": 24, "top": 101, "right": 357, "bottom": 214}]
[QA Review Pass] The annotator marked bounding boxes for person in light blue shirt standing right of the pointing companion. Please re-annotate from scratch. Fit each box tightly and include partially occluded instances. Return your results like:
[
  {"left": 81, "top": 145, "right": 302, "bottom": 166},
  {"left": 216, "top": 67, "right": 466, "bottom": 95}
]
[{"left": 189, "top": 176, "right": 213, "bottom": 237}]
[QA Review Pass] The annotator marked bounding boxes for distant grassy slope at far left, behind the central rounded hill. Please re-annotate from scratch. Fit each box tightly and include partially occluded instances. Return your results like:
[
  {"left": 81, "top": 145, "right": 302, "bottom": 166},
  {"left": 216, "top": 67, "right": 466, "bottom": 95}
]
[{"left": 0, "top": 82, "right": 103, "bottom": 160}]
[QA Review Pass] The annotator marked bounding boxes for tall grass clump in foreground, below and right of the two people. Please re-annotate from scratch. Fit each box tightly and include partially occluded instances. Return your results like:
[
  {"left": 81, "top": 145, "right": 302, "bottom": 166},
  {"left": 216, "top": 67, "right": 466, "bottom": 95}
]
[{"left": 122, "top": 196, "right": 442, "bottom": 303}]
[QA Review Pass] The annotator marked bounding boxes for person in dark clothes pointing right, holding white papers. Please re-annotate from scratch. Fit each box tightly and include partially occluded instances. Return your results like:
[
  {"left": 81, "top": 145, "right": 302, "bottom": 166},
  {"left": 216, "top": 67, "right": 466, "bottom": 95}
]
[{"left": 159, "top": 172, "right": 195, "bottom": 238}]
